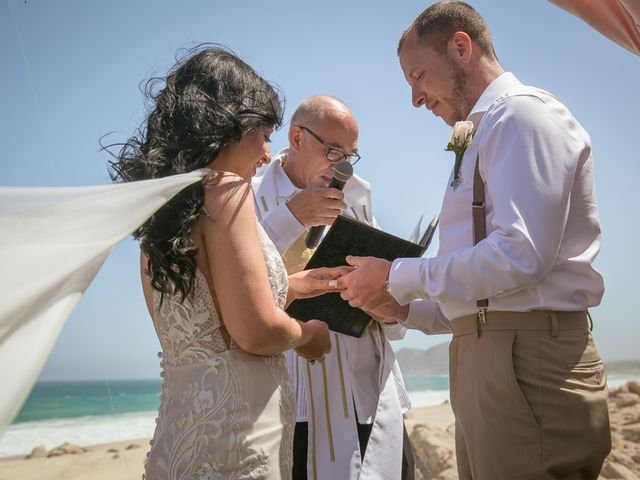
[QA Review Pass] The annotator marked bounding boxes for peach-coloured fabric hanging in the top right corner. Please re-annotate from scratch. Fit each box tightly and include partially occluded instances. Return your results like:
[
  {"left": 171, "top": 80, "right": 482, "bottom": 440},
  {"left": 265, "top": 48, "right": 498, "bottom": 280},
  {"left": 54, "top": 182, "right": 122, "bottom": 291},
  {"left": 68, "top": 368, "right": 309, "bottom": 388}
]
[{"left": 549, "top": 0, "right": 640, "bottom": 55}]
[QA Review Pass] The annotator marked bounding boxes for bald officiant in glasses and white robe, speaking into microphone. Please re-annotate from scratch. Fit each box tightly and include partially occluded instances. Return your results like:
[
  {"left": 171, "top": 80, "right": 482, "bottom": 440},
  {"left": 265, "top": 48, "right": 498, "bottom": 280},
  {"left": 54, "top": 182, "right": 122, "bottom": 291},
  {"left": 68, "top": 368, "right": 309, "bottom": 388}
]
[{"left": 253, "top": 96, "right": 413, "bottom": 480}]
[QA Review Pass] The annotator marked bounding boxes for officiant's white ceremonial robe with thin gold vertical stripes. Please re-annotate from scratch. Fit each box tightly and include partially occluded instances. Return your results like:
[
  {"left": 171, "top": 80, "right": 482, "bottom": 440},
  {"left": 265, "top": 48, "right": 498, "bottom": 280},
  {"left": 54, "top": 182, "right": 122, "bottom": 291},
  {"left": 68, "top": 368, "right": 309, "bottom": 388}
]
[{"left": 252, "top": 150, "right": 410, "bottom": 480}]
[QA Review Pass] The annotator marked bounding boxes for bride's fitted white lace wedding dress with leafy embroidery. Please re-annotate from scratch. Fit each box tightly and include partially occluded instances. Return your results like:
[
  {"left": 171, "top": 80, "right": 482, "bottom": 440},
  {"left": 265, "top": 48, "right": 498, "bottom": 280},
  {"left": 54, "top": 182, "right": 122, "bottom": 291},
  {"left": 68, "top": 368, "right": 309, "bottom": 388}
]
[{"left": 143, "top": 226, "right": 295, "bottom": 480}]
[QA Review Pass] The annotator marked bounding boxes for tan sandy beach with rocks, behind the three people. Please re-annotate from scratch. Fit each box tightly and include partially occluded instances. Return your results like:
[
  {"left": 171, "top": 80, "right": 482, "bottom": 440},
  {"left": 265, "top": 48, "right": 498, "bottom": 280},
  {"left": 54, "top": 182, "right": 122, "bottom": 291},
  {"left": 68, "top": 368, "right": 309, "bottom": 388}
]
[{"left": 0, "top": 382, "right": 640, "bottom": 480}]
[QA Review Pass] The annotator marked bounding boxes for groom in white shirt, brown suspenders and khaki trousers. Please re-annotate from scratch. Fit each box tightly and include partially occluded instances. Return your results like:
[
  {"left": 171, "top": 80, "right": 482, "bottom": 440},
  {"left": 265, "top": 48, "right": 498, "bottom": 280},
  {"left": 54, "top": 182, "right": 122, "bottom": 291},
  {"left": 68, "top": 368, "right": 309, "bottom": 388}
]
[{"left": 338, "top": 1, "right": 611, "bottom": 479}]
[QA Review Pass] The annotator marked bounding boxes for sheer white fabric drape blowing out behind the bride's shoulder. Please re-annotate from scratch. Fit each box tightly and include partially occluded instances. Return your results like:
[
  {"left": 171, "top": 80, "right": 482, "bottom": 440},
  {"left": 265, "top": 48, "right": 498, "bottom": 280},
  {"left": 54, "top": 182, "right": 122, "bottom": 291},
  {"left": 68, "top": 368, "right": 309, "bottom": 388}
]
[{"left": 0, "top": 169, "right": 209, "bottom": 432}]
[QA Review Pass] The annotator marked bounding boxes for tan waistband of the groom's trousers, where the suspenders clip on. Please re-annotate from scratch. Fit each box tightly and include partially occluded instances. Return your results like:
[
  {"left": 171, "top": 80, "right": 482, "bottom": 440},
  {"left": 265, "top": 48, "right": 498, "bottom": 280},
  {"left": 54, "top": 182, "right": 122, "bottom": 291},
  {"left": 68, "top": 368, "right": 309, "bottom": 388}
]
[{"left": 451, "top": 310, "right": 592, "bottom": 337}]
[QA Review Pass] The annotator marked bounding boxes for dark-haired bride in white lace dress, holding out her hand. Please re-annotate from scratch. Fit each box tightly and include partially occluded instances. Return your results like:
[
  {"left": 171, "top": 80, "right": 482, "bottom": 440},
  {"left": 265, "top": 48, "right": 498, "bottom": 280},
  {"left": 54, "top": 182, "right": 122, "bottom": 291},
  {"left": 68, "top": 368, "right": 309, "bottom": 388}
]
[{"left": 112, "top": 48, "right": 344, "bottom": 480}]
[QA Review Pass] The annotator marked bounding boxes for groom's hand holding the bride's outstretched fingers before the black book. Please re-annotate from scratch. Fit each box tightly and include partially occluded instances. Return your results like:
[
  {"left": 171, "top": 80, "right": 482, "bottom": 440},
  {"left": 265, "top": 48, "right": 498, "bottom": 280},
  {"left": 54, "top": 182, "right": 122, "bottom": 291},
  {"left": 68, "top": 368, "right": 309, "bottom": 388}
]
[{"left": 338, "top": 256, "right": 395, "bottom": 311}]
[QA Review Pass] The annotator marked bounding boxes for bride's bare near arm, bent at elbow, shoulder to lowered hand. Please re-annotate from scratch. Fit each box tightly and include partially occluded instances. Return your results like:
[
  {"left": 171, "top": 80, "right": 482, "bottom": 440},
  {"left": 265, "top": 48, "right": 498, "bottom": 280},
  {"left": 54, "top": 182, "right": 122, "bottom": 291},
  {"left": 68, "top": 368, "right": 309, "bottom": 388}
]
[{"left": 202, "top": 174, "right": 330, "bottom": 358}]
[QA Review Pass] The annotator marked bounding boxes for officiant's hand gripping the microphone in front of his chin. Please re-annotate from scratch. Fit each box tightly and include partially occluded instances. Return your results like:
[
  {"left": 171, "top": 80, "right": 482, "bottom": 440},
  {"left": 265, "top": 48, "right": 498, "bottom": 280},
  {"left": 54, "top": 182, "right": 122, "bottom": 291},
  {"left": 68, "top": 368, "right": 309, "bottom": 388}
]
[{"left": 287, "top": 187, "right": 346, "bottom": 228}]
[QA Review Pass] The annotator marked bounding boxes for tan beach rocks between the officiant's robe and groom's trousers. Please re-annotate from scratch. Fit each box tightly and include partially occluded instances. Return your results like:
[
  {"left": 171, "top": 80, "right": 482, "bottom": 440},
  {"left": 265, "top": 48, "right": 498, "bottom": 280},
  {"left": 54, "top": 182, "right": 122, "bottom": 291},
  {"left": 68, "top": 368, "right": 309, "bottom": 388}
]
[{"left": 411, "top": 424, "right": 458, "bottom": 480}]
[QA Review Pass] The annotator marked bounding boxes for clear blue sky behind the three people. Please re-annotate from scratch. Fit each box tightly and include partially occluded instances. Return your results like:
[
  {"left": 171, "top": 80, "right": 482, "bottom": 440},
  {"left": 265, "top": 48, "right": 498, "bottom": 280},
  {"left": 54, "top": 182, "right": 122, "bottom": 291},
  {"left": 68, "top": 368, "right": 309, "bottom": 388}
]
[{"left": 0, "top": 0, "right": 640, "bottom": 380}]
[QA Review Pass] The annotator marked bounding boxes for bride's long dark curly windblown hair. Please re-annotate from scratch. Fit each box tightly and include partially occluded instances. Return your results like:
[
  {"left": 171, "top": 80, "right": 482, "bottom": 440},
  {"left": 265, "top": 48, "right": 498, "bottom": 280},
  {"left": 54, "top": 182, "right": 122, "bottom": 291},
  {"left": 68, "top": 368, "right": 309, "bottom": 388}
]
[{"left": 109, "top": 46, "right": 282, "bottom": 298}]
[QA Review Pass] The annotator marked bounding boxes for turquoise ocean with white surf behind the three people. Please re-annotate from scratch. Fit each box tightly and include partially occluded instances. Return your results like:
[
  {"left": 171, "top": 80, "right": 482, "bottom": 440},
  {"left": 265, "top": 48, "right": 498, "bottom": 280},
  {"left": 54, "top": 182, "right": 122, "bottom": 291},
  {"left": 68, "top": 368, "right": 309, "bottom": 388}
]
[{"left": 0, "top": 375, "right": 638, "bottom": 457}]
